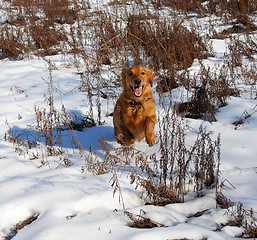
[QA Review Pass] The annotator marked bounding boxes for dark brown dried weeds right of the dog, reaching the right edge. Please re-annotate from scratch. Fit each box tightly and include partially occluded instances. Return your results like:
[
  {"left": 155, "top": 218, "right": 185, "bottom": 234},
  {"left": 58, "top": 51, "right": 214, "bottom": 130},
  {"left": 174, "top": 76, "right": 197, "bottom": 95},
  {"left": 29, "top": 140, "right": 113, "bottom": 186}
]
[{"left": 178, "top": 31, "right": 257, "bottom": 121}]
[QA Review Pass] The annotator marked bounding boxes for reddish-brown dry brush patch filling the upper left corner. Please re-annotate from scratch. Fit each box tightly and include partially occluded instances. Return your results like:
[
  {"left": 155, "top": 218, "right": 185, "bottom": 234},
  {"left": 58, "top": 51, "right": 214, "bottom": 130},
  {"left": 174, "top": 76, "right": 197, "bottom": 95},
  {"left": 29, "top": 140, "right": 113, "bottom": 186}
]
[{"left": 0, "top": 0, "right": 83, "bottom": 59}]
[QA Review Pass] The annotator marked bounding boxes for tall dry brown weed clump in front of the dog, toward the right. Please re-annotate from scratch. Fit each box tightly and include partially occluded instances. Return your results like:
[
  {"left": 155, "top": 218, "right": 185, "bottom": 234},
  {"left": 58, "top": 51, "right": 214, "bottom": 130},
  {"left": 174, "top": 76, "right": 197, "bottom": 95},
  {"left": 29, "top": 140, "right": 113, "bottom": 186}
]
[{"left": 85, "top": 109, "right": 220, "bottom": 206}]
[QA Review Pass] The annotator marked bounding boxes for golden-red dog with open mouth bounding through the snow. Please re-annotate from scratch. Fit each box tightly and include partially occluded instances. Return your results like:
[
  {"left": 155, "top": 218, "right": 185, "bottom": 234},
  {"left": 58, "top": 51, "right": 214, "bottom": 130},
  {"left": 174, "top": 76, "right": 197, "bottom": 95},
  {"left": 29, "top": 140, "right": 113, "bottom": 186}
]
[{"left": 113, "top": 66, "right": 156, "bottom": 146}]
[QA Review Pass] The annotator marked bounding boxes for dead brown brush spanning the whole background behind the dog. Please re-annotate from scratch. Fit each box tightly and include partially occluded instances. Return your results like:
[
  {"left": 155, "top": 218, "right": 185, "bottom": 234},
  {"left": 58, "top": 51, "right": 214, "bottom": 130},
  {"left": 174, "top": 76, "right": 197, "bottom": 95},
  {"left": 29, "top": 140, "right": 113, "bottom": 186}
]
[{"left": 0, "top": 0, "right": 257, "bottom": 106}]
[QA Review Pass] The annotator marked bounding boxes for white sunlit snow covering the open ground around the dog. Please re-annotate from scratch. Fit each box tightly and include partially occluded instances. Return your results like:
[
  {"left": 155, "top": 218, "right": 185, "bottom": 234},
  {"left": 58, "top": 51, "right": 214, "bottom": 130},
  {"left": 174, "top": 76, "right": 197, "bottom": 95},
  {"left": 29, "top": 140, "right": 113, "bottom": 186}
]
[{"left": 0, "top": 1, "right": 257, "bottom": 240}]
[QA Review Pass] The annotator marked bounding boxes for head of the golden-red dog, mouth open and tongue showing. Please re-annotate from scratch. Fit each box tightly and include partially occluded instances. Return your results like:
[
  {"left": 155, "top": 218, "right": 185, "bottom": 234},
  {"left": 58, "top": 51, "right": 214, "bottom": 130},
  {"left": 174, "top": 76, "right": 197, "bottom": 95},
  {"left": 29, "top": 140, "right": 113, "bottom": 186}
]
[{"left": 122, "top": 66, "right": 153, "bottom": 99}]
